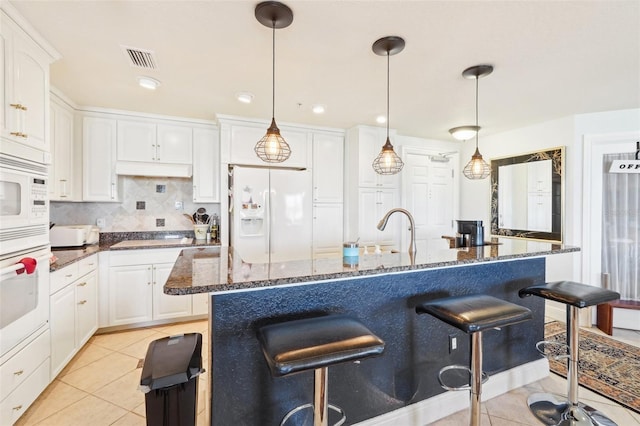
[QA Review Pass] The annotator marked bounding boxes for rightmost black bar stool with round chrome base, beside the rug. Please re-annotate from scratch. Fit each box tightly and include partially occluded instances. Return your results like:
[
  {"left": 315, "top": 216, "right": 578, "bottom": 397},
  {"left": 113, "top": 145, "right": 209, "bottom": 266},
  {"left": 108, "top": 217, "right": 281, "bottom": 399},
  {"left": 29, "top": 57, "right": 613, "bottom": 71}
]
[{"left": 519, "top": 281, "right": 620, "bottom": 426}]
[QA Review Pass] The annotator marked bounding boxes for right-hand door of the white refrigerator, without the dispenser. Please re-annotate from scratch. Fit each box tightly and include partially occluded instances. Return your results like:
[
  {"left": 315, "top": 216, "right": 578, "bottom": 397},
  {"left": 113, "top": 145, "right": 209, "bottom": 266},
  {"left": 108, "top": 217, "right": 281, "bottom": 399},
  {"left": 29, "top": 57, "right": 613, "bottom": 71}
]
[{"left": 268, "top": 170, "right": 313, "bottom": 262}]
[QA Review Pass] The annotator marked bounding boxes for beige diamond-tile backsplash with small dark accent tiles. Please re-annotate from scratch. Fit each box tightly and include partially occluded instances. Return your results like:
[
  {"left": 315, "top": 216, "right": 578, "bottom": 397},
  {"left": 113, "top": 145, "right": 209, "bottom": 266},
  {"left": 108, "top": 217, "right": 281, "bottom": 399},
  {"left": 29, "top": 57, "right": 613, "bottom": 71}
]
[{"left": 51, "top": 176, "right": 220, "bottom": 232}]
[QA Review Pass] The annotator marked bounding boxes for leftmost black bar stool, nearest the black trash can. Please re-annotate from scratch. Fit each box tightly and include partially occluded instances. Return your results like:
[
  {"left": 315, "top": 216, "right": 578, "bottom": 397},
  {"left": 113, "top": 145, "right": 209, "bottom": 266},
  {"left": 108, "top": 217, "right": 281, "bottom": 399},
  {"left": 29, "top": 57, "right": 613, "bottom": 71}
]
[{"left": 258, "top": 315, "right": 384, "bottom": 426}]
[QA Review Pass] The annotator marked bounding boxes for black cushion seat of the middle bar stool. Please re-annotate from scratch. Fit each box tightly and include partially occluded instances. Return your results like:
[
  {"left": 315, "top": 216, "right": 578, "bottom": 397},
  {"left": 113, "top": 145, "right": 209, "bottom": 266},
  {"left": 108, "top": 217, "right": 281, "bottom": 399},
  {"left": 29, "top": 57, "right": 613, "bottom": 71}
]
[{"left": 416, "top": 294, "right": 531, "bottom": 333}]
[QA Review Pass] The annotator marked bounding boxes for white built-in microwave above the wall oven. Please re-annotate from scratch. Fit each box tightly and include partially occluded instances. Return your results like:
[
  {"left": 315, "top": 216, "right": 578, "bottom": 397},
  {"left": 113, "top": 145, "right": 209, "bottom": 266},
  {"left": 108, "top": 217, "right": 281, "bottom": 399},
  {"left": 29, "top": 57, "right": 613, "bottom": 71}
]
[{"left": 0, "top": 154, "right": 49, "bottom": 254}]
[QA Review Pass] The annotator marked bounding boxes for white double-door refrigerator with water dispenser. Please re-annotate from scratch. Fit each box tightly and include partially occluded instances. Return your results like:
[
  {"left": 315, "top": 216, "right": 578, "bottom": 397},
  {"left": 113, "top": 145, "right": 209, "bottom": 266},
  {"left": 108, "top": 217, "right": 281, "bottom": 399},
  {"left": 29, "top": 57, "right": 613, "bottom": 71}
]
[{"left": 229, "top": 166, "right": 313, "bottom": 263}]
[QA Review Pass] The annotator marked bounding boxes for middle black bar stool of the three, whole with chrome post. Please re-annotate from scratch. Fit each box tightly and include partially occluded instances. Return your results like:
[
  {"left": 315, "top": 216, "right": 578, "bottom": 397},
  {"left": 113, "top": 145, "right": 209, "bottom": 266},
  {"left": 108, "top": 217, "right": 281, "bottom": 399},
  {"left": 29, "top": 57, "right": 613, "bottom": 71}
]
[{"left": 416, "top": 295, "right": 531, "bottom": 426}]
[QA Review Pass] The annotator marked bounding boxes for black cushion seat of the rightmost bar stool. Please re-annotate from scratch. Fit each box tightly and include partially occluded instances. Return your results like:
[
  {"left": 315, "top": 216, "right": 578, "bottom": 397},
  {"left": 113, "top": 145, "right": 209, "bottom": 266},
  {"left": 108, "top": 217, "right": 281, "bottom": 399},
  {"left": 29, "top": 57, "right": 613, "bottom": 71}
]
[{"left": 519, "top": 281, "right": 620, "bottom": 308}]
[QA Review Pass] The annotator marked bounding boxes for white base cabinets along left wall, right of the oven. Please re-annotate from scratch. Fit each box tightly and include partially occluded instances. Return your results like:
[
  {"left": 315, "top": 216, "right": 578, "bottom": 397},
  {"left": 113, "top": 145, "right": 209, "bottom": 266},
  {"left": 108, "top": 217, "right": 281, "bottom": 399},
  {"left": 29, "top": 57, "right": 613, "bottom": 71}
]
[{"left": 49, "top": 254, "right": 98, "bottom": 380}]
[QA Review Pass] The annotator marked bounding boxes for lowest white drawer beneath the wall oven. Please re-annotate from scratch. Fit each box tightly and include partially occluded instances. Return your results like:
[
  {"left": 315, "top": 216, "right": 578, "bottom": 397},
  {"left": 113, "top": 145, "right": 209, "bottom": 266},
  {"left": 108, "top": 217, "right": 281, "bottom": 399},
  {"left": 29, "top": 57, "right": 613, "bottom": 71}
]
[{"left": 0, "top": 359, "right": 49, "bottom": 425}]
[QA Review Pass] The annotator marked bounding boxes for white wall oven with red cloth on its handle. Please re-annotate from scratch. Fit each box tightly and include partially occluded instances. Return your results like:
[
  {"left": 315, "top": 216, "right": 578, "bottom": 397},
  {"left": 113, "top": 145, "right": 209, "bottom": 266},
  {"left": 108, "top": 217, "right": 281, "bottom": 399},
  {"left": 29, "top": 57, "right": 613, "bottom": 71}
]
[{"left": 0, "top": 246, "right": 51, "bottom": 359}]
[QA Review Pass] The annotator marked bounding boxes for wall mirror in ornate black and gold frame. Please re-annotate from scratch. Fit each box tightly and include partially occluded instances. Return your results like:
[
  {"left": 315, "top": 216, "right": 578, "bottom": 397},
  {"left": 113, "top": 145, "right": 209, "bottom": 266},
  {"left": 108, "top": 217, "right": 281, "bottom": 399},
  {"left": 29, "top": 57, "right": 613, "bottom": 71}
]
[{"left": 491, "top": 147, "right": 564, "bottom": 242}]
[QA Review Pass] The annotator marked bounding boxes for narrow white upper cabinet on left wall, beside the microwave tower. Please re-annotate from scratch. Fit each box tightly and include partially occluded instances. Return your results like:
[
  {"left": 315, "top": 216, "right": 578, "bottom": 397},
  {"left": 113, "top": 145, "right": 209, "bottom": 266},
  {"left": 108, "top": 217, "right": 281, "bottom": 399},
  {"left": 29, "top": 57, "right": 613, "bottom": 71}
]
[{"left": 49, "top": 95, "right": 82, "bottom": 201}]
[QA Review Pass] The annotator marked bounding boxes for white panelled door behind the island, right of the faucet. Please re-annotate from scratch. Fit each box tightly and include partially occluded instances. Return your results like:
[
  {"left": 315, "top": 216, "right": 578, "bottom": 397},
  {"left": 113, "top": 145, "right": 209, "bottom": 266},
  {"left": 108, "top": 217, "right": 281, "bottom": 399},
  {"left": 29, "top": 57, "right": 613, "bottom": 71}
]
[{"left": 402, "top": 148, "right": 456, "bottom": 254}]
